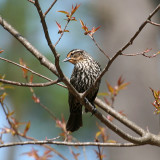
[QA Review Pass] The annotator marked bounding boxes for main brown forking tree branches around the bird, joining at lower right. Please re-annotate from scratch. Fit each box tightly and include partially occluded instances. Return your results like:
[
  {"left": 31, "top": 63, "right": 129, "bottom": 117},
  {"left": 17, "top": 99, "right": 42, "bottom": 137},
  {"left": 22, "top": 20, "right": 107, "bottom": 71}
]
[{"left": 0, "top": 0, "right": 160, "bottom": 147}]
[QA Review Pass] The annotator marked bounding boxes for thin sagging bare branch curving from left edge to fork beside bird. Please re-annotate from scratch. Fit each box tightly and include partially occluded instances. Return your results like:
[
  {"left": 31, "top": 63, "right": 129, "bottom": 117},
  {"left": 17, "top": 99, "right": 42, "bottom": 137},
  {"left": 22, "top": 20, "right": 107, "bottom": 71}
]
[{"left": 0, "top": 79, "right": 59, "bottom": 87}]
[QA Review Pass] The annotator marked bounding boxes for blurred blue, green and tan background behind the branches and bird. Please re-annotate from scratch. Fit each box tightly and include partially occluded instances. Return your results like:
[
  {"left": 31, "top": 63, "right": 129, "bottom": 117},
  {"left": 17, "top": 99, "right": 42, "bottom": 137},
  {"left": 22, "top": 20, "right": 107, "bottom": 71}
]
[{"left": 0, "top": 0, "right": 160, "bottom": 160}]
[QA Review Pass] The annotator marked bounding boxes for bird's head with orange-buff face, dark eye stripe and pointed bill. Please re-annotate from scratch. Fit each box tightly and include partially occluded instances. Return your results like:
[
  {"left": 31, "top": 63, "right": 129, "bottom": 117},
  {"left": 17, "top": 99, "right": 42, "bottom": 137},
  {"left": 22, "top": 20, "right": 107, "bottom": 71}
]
[{"left": 63, "top": 49, "right": 90, "bottom": 64}]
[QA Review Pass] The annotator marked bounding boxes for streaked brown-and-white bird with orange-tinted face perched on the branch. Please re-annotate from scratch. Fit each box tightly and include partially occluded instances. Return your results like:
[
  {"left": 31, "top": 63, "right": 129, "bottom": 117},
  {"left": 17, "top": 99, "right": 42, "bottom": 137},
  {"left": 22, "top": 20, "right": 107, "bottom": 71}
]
[{"left": 64, "top": 49, "right": 101, "bottom": 132}]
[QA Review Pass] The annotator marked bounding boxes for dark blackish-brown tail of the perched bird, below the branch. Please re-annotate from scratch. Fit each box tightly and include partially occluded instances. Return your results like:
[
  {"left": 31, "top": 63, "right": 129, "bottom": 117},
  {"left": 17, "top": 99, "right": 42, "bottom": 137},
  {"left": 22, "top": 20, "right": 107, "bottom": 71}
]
[{"left": 66, "top": 111, "right": 82, "bottom": 132}]
